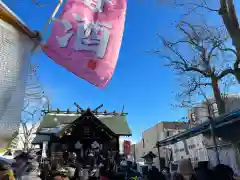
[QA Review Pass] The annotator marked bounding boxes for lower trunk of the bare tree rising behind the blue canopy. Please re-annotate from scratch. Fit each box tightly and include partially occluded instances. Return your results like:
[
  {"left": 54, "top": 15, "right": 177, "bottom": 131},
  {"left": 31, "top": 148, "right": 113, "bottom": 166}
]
[{"left": 211, "top": 76, "right": 226, "bottom": 114}]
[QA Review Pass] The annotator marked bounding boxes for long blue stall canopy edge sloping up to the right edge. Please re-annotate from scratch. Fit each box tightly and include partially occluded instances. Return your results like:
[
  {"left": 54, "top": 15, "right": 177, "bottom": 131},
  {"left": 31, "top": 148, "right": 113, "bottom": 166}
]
[{"left": 156, "top": 110, "right": 240, "bottom": 146}]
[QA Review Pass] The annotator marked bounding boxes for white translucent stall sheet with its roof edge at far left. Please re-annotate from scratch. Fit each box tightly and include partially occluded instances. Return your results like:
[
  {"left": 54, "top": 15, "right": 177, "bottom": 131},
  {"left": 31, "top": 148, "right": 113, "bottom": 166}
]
[{"left": 0, "top": 1, "right": 40, "bottom": 151}]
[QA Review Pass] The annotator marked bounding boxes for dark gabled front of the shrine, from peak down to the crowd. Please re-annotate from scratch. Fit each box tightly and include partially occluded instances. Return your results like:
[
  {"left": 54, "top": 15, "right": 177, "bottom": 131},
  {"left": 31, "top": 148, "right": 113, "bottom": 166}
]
[{"left": 45, "top": 110, "right": 122, "bottom": 167}]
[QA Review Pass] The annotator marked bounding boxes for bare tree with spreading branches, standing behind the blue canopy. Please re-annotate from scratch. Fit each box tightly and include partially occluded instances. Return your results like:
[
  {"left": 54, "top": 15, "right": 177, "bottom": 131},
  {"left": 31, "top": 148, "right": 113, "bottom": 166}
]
[{"left": 153, "top": 21, "right": 233, "bottom": 114}]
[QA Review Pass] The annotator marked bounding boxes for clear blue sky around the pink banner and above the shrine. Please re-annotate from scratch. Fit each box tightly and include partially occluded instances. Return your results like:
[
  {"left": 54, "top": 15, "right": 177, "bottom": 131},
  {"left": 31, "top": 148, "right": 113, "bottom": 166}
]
[{"left": 4, "top": 0, "right": 238, "bottom": 141}]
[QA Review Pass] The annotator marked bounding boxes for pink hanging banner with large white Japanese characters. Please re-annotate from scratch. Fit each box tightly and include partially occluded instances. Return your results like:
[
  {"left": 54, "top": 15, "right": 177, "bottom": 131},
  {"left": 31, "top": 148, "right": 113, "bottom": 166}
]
[{"left": 43, "top": 0, "right": 127, "bottom": 88}]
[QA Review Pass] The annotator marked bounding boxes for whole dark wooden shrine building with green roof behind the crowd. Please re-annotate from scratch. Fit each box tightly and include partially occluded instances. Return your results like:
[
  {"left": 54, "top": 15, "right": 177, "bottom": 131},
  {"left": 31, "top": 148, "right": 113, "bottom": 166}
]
[{"left": 33, "top": 105, "right": 131, "bottom": 176}]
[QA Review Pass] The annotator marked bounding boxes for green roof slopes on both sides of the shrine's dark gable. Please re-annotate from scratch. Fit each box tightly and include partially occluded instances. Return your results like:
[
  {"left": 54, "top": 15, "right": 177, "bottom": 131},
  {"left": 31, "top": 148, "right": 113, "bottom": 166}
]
[{"left": 38, "top": 112, "right": 132, "bottom": 136}]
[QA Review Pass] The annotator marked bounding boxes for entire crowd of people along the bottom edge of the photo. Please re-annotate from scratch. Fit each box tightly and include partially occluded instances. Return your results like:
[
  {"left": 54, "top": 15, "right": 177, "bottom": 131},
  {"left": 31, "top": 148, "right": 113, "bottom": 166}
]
[{"left": 0, "top": 150, "right": 237, "bottom": 180}]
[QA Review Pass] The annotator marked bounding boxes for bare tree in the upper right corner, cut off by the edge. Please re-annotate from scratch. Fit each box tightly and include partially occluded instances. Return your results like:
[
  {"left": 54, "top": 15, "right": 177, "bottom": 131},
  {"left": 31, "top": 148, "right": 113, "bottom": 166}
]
[{"left": 160, "top": 0, "right": 240, "bottom": 83}]
